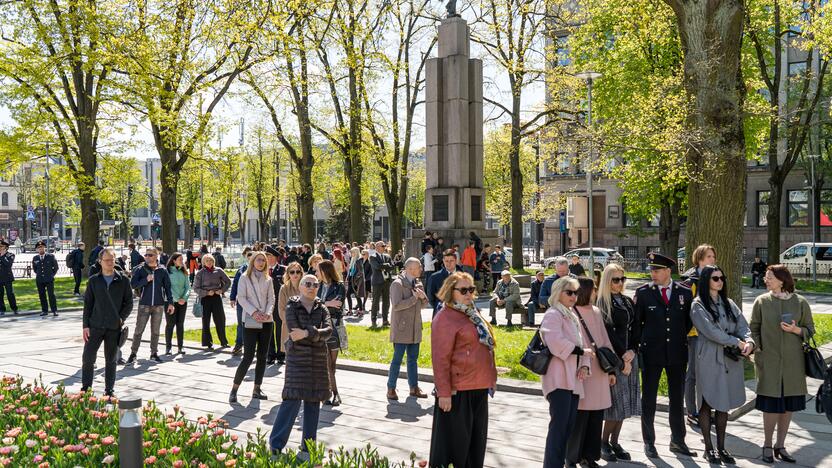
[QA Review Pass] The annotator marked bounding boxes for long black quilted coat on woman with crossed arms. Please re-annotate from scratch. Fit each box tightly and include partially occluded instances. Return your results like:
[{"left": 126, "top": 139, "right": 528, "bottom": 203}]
[{"left": 283, "top": 296, "right": 332, "bottom": 401}]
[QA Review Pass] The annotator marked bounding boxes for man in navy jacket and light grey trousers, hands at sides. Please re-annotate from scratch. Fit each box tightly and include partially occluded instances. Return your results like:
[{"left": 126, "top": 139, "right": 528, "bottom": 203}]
[{"left": 127, "top": 247, "right": 173, "bottom": 364}]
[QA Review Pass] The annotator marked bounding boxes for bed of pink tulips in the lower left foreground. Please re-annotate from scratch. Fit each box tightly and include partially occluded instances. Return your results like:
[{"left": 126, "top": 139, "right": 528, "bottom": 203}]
[{"left": 0, "top": 377, "right": 424, "bottom": 468}]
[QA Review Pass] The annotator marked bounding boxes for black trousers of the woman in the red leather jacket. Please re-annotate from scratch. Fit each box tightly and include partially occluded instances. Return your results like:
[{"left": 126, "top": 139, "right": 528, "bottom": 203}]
[{"left": 430, "top": 389, "right": 488, "bottom": 468}]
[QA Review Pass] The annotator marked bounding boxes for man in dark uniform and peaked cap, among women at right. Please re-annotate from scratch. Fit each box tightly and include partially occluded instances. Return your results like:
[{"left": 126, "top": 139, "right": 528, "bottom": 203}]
[{"left": 634, "top": 253, "right": 696, "bottom": 458}]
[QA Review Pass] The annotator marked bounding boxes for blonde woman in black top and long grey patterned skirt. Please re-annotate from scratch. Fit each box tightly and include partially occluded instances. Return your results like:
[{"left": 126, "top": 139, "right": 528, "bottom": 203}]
[{"left": 596, "top": 263, "right": 641, "bottom": 462}]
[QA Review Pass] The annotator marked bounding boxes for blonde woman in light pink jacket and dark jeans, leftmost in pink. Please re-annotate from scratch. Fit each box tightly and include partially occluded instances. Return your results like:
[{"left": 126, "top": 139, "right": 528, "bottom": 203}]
[{"left": 540, "top": 276, "right": 600, "bottom": 468}]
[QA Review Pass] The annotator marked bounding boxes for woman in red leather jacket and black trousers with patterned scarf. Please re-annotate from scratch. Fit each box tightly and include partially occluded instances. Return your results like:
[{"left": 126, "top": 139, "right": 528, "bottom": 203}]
[{"left": 430, "top": 272, "right": 497, "bottom": 467}]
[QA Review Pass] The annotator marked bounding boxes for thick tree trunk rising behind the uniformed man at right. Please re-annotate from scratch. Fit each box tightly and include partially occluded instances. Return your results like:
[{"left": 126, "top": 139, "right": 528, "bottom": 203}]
[{"left": 666, "top": 0, "right": 747, "bottom": 304}]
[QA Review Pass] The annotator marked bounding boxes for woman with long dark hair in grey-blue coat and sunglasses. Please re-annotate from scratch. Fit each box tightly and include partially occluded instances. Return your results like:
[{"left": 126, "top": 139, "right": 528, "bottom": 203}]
[{"left": 690, "top": 265, "right": 754, "bottom": 465}]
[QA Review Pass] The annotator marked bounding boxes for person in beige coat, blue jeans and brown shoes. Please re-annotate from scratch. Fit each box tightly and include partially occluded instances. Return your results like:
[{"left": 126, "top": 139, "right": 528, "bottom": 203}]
[{"left": 387, "top": 257, "right": 428, "bottom": 400}]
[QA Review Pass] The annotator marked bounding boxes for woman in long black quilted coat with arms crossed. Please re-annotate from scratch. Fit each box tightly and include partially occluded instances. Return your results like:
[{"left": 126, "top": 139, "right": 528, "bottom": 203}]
[{"left": 269, "top": 272, "right": 333, "bottom": 460}]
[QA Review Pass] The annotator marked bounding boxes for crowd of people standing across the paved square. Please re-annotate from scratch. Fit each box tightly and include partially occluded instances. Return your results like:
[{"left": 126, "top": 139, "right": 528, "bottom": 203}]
[{"left": 0, "top": 233, "right": 814, "bottom": 468}]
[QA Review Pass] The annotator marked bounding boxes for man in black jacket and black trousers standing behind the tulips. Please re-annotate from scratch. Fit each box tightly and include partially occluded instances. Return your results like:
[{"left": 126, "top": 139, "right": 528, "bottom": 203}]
[{"left": 81, "top": 248, "right": 133, "bottom": 396}]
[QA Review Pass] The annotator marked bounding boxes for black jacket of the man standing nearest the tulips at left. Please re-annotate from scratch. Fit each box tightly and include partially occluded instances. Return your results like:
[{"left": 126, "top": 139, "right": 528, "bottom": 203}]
[{"left": 83, "top": 271, "right": 133, "bottom": 330}]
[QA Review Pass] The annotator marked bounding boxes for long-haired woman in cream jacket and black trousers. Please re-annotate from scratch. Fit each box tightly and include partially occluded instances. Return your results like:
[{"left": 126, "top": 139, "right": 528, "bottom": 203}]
[{"left": 228, "top": 252, "right": 275, "bottom": 403}]
